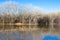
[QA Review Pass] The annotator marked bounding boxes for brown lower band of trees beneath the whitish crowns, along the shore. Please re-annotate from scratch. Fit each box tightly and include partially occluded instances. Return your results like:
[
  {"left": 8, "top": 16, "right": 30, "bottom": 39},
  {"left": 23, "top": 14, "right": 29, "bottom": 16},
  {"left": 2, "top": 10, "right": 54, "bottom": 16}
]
[{"left": 0, "top": 14, "right": 60, "bottom": 27}]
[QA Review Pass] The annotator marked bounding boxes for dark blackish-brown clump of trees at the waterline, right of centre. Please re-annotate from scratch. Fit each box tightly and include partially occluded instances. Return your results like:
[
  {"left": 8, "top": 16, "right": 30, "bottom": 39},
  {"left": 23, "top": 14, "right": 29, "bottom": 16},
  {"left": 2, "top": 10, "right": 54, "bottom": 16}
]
[{"left": 37, "top": 17, "right": 50, "bottom": 28}]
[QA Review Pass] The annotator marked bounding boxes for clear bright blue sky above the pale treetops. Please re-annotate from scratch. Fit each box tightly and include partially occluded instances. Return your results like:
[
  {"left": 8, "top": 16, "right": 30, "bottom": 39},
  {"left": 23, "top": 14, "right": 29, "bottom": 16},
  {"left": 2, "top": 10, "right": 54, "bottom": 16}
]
[{"left": 0, "top": 0, "right": 60, "bottom": 12}]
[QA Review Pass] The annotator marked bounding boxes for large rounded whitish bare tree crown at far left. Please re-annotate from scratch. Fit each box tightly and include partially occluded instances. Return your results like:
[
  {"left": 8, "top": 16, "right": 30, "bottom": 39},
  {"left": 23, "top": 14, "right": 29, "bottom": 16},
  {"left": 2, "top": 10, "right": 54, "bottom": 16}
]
[{"left": 0, "top": 1, "right": 20, "bottom": 13}]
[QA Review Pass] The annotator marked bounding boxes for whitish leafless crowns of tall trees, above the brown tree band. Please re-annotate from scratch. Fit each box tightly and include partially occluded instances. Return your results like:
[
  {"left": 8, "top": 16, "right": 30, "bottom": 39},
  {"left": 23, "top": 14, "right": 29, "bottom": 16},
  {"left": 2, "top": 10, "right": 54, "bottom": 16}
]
[{"left": 0, "top": 1, "right": 43, "bottom": 13}]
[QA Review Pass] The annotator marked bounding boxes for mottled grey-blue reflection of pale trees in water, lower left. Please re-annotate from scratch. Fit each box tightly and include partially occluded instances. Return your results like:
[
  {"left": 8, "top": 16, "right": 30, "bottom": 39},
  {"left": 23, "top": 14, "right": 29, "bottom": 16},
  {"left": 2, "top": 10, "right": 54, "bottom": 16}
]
[{"left": 0, "top": 32, "right": 33, "bottom": 40}]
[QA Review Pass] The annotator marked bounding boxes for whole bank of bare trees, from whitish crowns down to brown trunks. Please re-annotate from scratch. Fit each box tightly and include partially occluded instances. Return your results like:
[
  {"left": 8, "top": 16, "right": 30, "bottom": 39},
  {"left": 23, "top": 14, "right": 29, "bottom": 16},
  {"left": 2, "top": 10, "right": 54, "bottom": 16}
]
[{"left": 0, "top": 3, "right": 60, "bottom": 29}]
